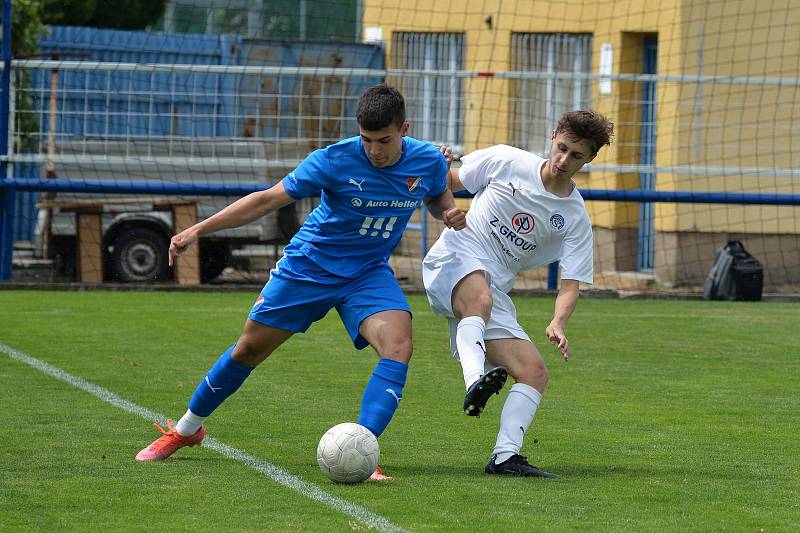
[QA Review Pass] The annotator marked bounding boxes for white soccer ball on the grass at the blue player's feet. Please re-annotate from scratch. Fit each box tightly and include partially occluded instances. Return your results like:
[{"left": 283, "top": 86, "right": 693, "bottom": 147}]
[{"left": 317, "top": 422, "right": 381, "bottom": 483}]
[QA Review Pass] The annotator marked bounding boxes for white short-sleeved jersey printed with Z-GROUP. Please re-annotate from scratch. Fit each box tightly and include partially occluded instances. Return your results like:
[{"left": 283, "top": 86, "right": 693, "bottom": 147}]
[{"left": 425, "top": 144, "right": 593, "bottom": 293}]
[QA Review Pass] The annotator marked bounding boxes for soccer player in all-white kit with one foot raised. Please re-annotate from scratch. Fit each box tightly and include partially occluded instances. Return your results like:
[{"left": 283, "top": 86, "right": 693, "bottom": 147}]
[{"left": 423, "top": 111, "right": 614, "bottom": 478}]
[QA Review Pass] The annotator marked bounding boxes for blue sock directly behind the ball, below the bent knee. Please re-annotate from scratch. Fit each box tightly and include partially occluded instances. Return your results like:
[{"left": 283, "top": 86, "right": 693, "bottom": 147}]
[{"left": 358, "top": 359, "right": 408, "bottom": 437}]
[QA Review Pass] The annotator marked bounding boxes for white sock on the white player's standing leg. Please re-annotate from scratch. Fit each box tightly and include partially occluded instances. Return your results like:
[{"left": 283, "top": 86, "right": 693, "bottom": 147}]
[{"left": 492, "top": 383, "right": 542, "bottom": 464}]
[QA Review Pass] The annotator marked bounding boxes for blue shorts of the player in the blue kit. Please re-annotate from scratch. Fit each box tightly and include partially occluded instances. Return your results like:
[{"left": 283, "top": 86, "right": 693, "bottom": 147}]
[{"left": 250, "top": 255, "right": 411, "bottom": 350}]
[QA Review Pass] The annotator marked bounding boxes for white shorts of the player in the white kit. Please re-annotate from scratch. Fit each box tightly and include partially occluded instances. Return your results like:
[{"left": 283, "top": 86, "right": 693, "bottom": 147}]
[{"left": 422, "top": 253, "right": 531, "bottom": 359}]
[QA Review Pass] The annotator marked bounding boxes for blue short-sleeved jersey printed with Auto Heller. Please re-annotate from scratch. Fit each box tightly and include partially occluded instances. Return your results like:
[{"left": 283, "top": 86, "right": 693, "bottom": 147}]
[{"left": 283, "top": 137, "right": 447, "bottom": 277}]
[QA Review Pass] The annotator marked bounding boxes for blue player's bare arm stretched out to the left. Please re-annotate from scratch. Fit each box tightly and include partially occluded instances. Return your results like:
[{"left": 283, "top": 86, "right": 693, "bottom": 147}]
[{"left": 169, "top": 182, "right": 294, "bottom": 266}]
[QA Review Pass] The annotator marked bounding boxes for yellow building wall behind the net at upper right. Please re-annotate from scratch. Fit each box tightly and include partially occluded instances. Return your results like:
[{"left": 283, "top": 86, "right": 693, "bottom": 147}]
[{"left": 363, "top": 0, "right": 800, "bottom": 232}]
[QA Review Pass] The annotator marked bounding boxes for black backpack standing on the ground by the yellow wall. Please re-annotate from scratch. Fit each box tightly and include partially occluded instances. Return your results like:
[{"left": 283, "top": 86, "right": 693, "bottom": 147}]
[{"left": 703, "top": 241, "right": 764, "bottom": 301}]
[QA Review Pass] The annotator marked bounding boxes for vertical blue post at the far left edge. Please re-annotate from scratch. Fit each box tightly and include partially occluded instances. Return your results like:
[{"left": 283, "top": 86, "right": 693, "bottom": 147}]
[{"left": 0, "top": 0, "right": 16, "bottom": 281}]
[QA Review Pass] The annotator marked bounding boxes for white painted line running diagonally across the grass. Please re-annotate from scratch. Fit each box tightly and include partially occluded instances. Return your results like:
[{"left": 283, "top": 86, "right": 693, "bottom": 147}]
[{"left": 0, "top": 342, "right": 405, "bottom": 533}]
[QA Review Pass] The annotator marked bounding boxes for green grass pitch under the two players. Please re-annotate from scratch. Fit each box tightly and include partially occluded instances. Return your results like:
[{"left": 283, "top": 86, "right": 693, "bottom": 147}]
[{"left": 0, "top": 291, "right": 800, "bottom": 532}]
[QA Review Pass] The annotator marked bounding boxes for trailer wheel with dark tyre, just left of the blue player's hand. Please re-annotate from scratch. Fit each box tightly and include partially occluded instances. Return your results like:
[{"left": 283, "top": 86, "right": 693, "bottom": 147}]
[{"left": 110, "top": 228, "right": 170, "bottom": 282}]
